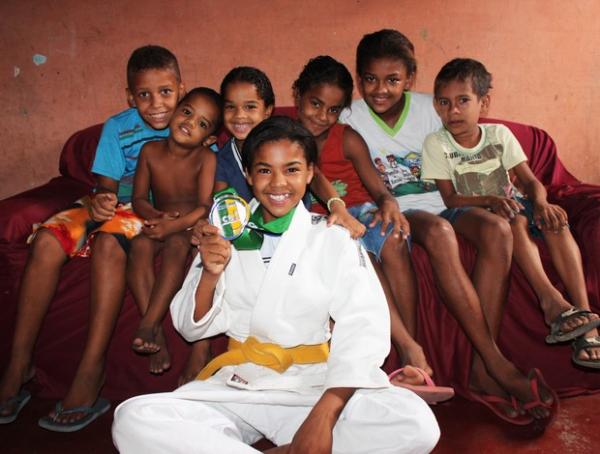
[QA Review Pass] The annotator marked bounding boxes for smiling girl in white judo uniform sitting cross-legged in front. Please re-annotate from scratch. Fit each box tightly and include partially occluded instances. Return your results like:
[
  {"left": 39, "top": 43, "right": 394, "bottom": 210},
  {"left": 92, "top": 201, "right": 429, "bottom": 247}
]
[{"left": 113, "top": 117, "right": 439, "bottom": 454}]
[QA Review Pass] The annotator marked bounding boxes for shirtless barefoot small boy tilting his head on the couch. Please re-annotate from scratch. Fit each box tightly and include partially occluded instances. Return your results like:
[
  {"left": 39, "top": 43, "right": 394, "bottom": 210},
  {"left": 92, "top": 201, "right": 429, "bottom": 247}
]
[{"left": 127, "top": 87, "right": 222, "bottom": 374}]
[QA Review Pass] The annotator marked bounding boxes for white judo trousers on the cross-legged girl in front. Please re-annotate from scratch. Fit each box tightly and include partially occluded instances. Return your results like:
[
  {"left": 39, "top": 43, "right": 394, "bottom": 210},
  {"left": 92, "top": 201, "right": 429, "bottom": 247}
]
[{"left": 112, "top": 385, "right": 440, "bottom": 454}]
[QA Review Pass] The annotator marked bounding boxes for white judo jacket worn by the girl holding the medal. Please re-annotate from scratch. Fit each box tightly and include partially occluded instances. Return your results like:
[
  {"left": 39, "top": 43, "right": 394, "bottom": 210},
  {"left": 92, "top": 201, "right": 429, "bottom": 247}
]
[{"left": 171, "top": 204, "right": 390, "bottom": 406}]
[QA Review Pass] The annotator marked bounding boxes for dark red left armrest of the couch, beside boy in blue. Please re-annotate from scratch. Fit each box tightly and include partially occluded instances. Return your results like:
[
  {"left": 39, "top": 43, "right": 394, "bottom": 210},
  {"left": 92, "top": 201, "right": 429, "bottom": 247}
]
[{"left": 0, "top": 177, "right": 91, "bottom": 243}]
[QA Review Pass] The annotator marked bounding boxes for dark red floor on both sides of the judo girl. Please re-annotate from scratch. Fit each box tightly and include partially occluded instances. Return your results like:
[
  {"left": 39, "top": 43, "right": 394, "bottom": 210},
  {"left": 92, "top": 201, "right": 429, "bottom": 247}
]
[{"left": 0, "top": 394, "right": 600, "bottom": 454}]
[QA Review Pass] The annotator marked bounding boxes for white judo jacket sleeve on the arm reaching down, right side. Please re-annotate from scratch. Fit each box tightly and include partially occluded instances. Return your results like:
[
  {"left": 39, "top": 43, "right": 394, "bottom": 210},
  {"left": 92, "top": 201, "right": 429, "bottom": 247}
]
[{"left": 325, "top": 239, "right": 390, "bottom": 389}]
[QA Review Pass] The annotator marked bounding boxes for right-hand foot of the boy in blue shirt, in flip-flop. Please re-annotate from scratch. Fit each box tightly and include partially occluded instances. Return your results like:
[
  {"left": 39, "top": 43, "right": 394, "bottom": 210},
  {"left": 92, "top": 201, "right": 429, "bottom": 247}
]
[{"left": 50, "top": 364, "right": 105, "bottom": 424}]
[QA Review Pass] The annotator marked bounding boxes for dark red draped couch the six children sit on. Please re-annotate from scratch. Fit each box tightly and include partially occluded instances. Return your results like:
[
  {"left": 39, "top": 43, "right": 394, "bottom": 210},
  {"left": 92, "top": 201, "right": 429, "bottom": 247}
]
[{"left": 0, "top": 114, "right": 600, "bottom": 399}]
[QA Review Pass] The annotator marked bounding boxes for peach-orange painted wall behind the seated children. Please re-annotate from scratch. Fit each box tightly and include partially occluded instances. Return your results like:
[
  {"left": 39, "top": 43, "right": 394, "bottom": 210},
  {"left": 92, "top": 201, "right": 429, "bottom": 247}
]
[{"left": 0, "top": 0, "right": 600, "bottom": 198}]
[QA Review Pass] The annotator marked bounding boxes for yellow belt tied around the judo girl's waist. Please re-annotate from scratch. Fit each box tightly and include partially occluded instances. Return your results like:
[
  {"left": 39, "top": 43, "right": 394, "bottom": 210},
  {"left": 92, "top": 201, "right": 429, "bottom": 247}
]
[{"left": 196, "top": 336, "right": 329, "bottom": 380}]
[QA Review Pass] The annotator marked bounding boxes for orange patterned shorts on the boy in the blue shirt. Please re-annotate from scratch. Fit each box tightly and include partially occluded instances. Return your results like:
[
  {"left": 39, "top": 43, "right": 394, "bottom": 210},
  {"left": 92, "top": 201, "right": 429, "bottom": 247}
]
[{"left": 27, "top": 196, "right": 144, "bottom": 257}]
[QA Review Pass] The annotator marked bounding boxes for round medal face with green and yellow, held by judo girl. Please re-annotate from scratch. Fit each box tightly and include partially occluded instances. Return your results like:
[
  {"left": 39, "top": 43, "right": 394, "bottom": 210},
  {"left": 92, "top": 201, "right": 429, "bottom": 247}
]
[{"left": 208, "top": 194, "right": 250, "bottom": 240}]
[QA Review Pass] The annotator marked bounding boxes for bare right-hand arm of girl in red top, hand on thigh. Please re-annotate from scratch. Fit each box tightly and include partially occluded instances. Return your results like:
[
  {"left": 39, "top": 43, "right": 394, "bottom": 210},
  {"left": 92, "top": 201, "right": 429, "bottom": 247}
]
[{"left": 344, "top": 127, "right": 410, "bottom": 239}]
